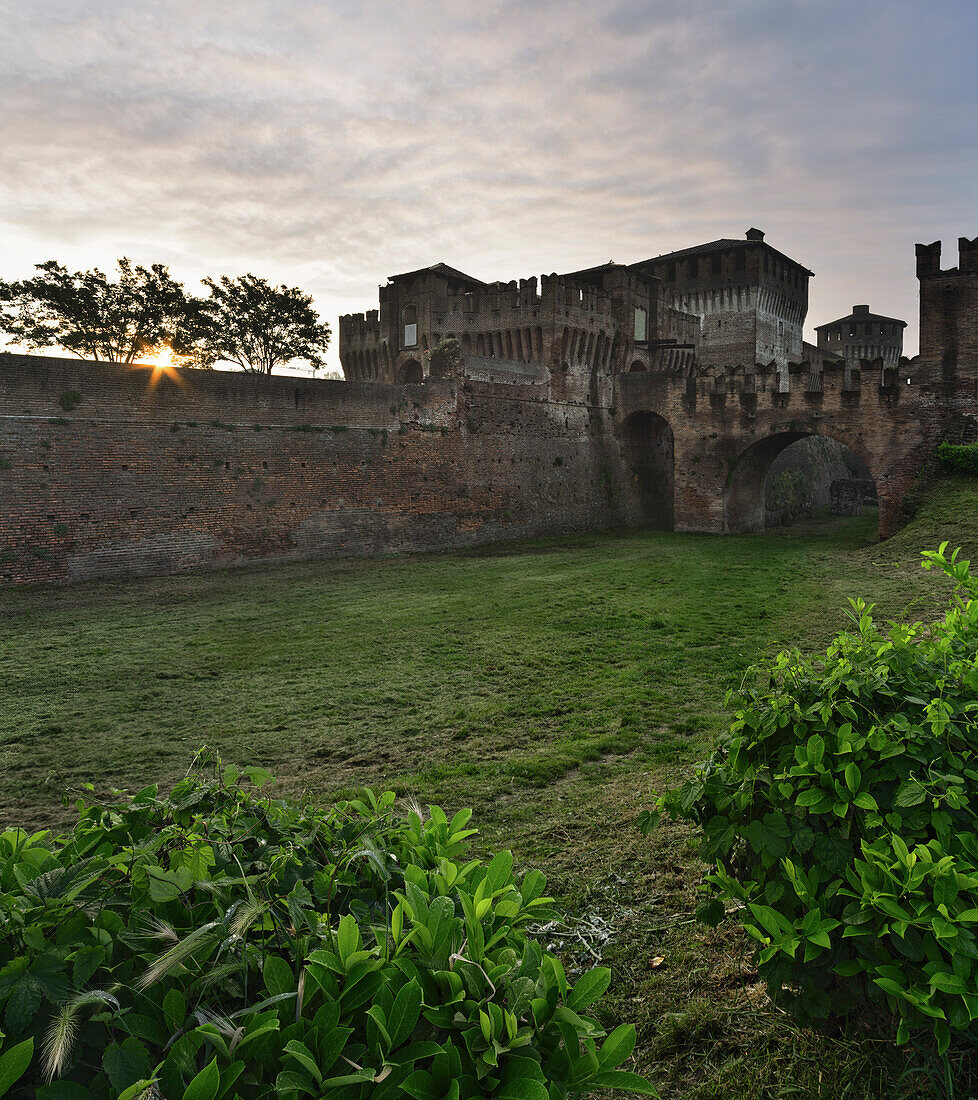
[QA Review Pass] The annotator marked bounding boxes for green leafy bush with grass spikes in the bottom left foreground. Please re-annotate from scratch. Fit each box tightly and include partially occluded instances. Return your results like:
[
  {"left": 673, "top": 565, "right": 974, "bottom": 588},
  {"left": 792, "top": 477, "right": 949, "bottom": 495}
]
[{"left": 0, "top": 763, "right": 651, "bottom": 1100}]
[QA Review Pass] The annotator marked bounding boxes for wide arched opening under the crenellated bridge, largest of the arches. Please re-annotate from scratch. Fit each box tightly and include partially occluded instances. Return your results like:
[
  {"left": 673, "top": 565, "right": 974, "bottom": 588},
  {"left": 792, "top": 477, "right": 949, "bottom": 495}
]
[{"left": 725, "top": 431, "right": 879, "bottom": 532}]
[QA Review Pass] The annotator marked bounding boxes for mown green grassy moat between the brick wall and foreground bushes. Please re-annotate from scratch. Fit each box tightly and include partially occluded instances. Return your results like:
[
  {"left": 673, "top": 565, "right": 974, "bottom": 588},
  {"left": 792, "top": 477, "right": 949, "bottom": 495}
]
[{"left": 0, "top": 480, "right": 978, "bottom": 1098}]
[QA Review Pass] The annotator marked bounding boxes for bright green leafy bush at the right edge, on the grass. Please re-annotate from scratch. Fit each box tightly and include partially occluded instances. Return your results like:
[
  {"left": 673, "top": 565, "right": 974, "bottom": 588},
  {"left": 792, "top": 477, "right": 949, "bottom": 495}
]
[{"left": 641, "top": 542, "right": 978, "bottom": 1052}]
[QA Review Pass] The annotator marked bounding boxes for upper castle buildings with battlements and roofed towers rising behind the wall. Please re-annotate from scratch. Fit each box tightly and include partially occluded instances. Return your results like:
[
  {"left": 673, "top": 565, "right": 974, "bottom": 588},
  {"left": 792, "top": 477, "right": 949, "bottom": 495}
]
[{"left": 340, "top": 228, "right": 862, "bottom": 388}]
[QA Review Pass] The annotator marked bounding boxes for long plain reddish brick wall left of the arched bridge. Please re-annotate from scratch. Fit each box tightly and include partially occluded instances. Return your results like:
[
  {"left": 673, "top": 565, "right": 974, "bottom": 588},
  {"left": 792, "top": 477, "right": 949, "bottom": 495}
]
[{"left": 0, "top": 355, "right": 627, "bottom": 583}]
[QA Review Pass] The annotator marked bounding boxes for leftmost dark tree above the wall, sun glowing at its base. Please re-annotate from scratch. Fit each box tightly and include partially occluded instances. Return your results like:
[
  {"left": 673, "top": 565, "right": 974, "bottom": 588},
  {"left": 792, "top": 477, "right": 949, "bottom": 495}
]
[{"left": 0, "top": 256, "right": 187, "bottom": 363}]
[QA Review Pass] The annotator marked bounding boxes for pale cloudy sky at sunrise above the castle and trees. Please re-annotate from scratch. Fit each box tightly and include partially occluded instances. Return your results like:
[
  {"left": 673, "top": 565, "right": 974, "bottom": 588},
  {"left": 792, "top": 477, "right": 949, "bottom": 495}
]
[{"left": 0, "top": 0, "right": 978, "bottom": 371}]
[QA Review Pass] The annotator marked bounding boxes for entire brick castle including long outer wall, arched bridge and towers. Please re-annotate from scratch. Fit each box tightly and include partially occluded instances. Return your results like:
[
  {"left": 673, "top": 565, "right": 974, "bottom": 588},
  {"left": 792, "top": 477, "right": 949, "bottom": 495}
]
[{"left": 0, "top": 230, "right": 978, "bottom": 584}]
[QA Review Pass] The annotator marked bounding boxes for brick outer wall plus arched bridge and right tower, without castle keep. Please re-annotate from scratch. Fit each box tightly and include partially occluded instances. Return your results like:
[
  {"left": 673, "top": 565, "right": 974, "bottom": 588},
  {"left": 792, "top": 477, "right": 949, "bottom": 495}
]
[{"left": 0, "top": 239, "right": 978, "bottom": 584}]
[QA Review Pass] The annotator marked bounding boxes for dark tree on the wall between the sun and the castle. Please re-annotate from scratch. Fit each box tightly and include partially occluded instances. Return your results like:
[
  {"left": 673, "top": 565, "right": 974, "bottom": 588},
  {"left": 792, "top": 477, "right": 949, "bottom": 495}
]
[{"left": 182, "top": 274, "right": 331, "bottom": 374}]
